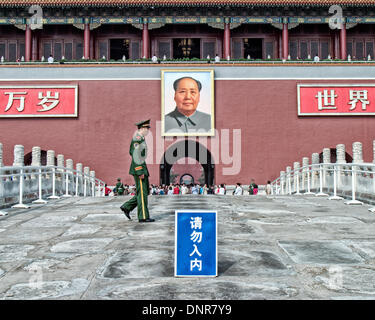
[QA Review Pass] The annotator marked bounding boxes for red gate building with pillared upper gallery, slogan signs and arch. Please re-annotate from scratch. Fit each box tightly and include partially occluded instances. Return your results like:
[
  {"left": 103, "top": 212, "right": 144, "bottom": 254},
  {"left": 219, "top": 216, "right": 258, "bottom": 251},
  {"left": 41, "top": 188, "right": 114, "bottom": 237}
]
[{"left": 0, "top": 0, "right": 375, "bottom": 185}]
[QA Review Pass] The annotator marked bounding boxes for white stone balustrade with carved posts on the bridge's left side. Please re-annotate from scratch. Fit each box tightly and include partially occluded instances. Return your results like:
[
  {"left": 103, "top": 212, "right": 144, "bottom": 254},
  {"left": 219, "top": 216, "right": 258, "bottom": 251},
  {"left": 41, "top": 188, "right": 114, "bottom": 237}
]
[{"left": 0, "top": 143, "right": 105, "bottom": 214}]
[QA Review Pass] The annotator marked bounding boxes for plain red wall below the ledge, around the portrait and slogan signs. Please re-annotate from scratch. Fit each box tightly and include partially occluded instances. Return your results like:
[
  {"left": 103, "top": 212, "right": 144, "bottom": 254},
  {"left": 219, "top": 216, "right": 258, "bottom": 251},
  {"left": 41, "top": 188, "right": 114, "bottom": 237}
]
[{"left": 0, "top": 80, "right": 375, "bottom": 185}]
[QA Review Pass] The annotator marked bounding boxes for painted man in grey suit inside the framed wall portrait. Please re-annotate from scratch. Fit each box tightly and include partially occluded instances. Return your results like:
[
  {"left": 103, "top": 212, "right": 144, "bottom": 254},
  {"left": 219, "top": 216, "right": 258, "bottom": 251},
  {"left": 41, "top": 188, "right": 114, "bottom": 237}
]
[{"left": 164, "top": 77, "right": 211, "bottom": 133}]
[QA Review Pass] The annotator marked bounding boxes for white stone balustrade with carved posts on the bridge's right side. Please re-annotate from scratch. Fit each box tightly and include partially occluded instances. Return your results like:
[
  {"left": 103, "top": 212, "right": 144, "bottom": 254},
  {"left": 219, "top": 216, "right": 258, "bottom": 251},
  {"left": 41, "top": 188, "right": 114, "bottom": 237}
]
[{"left": 271, "top": 140, "right": 375, "bottom": 212}]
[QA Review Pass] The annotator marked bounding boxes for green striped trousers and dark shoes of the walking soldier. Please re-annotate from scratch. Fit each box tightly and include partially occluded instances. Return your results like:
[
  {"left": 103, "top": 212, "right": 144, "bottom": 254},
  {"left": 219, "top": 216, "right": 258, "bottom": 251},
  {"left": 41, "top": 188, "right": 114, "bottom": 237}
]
[{"left": 121, "top": 176, "right": 150, "bottom": 220}]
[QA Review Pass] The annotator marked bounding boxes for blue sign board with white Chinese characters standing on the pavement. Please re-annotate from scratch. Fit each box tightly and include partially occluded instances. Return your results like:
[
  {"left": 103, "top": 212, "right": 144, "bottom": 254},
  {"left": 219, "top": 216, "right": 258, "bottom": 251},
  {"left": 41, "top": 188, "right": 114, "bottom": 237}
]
[{"left": 175, "top": 210, "right": 217, "bottom": 277}]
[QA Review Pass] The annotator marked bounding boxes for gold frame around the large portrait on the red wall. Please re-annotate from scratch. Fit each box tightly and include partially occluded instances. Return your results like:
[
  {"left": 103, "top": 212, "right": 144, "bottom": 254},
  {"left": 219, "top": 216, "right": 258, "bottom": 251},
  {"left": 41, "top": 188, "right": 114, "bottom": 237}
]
[{"left": 161, "top": 69, "right": 215, "bottom": 137}]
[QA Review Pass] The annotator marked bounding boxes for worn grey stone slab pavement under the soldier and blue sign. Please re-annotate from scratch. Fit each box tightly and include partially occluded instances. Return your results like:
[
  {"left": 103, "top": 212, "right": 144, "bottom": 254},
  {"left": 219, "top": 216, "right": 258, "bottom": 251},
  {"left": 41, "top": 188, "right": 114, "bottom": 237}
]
[{"left": 0, "top": 195, "right": 375, "bottom": 300}]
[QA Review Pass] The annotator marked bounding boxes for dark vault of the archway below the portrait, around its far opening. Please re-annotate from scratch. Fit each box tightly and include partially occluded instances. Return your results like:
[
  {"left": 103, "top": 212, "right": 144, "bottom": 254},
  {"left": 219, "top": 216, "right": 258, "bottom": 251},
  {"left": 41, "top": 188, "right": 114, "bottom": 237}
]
[{"left": 160, "top": 139, "right": 215, "bottom": 186}]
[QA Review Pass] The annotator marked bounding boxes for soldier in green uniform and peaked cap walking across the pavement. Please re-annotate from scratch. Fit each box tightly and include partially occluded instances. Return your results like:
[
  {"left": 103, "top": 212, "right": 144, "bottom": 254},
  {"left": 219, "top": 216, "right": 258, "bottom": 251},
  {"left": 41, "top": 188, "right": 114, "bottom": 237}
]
[{"left": 120, "top": 120, "right": 155, "bottom": 222}]
